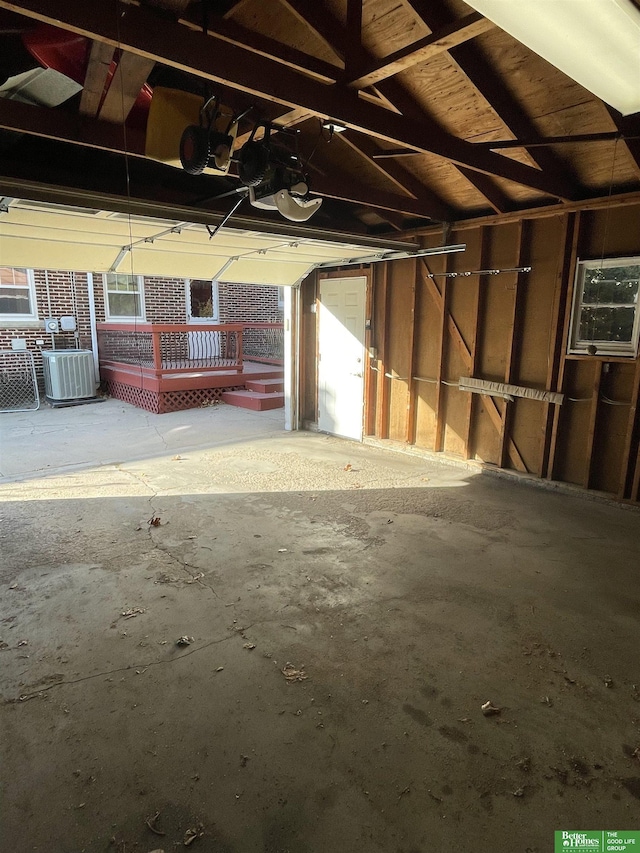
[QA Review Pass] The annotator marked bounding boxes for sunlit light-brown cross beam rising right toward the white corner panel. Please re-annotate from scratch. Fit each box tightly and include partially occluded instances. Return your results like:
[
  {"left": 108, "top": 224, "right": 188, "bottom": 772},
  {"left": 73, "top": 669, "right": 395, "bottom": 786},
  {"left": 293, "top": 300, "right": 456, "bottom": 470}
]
[{"left": 349, "top": 12, "right": 495, "bottom": 89}]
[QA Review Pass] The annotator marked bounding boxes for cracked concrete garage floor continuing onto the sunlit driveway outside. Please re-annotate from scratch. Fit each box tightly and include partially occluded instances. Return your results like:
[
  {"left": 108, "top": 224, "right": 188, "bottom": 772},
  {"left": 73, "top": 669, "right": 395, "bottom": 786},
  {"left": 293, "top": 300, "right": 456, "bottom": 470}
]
[{"left": 0, "top": 400, "right": 640, "bottom": 853}]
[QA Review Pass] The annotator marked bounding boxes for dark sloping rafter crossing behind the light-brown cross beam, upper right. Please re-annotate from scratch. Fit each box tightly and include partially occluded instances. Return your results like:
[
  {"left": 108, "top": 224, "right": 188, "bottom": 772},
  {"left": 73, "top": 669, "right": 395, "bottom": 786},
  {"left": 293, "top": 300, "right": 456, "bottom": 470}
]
[{"left": 407, "top": 0, "right": 582, "bottom": 198}]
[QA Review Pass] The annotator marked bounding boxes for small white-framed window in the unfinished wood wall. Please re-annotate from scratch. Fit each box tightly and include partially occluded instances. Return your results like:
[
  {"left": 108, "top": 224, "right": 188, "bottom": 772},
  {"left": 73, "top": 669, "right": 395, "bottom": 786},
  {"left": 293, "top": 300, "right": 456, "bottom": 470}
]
[{"left": 569, "top": 258, "right": 640, "bottom": 357}]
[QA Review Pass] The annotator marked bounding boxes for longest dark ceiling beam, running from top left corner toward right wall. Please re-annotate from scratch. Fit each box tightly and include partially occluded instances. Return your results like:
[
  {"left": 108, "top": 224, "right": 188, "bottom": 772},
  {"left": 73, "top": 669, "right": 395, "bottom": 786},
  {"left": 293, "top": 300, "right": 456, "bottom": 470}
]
[{"left": 0, "top": 0, "right": 574, "bottom": 199}]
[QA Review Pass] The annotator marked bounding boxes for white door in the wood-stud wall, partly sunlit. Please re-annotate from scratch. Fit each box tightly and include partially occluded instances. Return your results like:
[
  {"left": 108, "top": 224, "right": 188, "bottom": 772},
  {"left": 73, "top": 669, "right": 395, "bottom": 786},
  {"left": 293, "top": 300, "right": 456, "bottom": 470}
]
[{"left": 318, "top": 276, "right": 367, "bottom": 441}]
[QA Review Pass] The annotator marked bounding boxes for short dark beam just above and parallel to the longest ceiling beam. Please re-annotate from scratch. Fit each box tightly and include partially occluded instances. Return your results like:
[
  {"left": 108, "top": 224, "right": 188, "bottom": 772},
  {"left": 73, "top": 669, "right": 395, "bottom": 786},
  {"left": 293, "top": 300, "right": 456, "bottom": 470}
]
[{"left": 180, "top": 12, "right": 342, "bottom": 83}]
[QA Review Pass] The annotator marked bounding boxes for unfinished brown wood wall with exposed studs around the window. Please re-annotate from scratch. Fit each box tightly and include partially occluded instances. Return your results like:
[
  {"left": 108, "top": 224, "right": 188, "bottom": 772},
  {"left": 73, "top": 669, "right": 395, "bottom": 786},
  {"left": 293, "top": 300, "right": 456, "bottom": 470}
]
[{"left": 302, "top": 203, "right": 640, "bottom": 502}]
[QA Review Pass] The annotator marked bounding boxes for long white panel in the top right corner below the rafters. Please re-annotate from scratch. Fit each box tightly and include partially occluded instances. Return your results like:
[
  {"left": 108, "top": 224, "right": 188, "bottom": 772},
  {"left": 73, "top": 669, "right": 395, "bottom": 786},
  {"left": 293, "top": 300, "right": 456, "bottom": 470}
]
[{"left": 465, "top": 0, "right": 640, "bottom": 115}]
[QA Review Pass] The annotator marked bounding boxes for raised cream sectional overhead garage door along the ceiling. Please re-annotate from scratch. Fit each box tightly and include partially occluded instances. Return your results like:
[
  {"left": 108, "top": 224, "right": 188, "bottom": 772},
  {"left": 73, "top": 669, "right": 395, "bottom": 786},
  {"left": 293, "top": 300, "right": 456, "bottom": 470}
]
[{"left": 0, "top": 199, "right": 404, "bottom": 286}]
